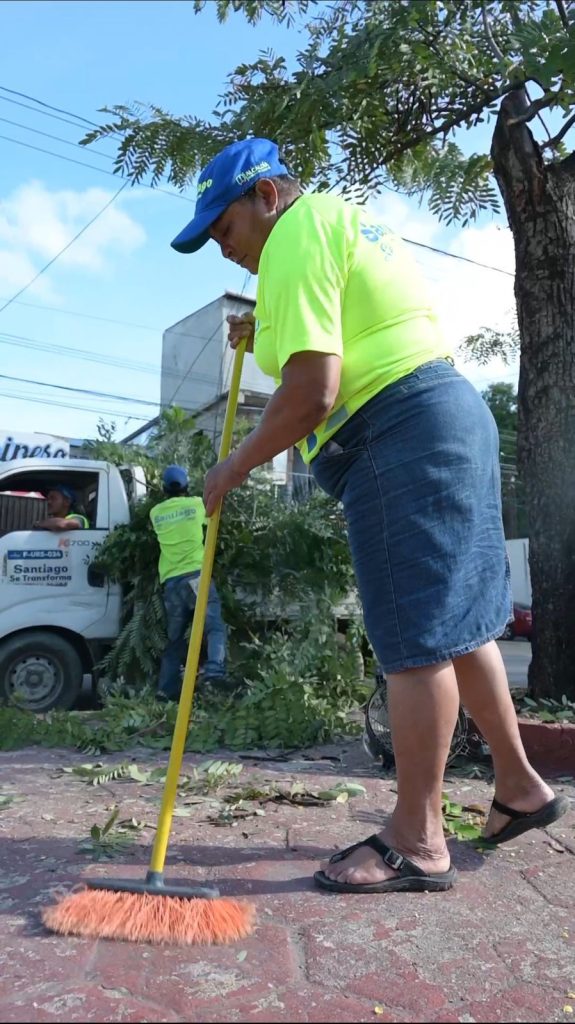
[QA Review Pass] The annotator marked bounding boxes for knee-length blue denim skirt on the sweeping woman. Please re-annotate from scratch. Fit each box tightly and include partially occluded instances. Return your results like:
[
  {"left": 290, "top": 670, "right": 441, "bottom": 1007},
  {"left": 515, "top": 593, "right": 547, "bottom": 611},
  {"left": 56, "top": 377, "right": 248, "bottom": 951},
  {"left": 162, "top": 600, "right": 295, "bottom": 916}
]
[{"left": 311, "top": 359, "right": 512, "bottom": 674}]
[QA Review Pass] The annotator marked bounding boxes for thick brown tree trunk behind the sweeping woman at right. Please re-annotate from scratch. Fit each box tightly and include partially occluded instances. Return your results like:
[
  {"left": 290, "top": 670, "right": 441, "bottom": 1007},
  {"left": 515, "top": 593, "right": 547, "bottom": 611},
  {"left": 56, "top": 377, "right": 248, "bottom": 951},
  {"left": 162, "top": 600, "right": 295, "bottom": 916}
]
[{"left": 491, "top": 90, "right": 575, "bottom": 700}]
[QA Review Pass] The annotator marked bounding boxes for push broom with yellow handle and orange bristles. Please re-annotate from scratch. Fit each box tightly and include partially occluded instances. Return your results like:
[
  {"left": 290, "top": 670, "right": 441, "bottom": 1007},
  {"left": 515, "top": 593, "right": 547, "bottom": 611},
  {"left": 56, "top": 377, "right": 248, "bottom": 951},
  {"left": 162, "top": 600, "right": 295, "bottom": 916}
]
[{"left": 42, "top": 342, "right": 255, "bottom": 945}]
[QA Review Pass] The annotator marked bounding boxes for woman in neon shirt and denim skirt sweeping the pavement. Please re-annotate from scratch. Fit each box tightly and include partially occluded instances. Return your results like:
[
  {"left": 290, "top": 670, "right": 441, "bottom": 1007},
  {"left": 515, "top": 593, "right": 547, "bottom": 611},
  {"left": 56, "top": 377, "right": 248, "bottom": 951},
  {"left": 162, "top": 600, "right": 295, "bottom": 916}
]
[{"left": 172, "top": 138, "right": 568, "bottom": 893}]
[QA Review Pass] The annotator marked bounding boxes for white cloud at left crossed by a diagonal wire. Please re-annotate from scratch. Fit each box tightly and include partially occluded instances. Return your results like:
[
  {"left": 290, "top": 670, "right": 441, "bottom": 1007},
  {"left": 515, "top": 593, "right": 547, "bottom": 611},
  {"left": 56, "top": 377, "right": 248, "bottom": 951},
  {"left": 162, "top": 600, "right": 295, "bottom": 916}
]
[{"left": 0, "top": 181, "right": 145, "bottom": 294}]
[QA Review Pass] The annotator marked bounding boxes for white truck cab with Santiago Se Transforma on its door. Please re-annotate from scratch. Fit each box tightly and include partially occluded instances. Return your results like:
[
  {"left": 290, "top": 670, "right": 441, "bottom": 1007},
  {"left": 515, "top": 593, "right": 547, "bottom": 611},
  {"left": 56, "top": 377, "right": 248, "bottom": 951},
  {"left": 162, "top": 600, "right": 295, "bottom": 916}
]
[{"left": 0, "top": 459, "right": 145, "bottom": 713}]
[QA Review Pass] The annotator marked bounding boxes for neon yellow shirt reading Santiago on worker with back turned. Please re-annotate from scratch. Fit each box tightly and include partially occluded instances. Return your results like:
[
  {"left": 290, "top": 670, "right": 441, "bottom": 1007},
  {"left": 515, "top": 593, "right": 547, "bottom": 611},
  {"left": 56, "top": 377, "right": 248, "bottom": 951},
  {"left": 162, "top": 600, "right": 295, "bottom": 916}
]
[{"left": 149, "top": 495, "right": 207, "bottom": 583}]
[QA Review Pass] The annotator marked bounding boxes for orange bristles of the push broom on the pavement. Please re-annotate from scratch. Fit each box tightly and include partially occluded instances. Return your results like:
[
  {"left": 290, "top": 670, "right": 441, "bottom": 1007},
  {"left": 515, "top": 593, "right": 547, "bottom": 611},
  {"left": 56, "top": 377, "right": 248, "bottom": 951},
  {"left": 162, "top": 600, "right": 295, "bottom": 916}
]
[{"left": 42, "top": 889, "right": 255, "bottom": 946}]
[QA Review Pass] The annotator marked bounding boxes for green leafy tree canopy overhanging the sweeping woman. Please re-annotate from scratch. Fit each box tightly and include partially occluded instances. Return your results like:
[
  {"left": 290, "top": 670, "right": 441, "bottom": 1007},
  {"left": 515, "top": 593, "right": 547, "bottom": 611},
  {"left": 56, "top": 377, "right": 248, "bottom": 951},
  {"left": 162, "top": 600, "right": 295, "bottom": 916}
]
[{"left": 83, "top": 0, "right": 575, "bottom": 223}]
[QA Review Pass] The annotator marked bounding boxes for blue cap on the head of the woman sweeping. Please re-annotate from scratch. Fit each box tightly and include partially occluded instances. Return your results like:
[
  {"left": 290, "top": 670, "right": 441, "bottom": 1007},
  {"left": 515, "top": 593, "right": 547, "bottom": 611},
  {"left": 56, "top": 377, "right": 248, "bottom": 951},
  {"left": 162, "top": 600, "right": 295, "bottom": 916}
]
[{"left": 172, "top": 138, "right": 290, "bottom": 253}]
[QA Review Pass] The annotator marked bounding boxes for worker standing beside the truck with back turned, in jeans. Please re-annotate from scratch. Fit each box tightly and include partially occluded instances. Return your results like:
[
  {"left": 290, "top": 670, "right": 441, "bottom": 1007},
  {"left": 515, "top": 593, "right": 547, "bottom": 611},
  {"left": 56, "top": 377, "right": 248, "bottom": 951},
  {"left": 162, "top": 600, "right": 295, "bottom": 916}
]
[{"left": 149, "top": 466, "right": 226, "bottom": 700}]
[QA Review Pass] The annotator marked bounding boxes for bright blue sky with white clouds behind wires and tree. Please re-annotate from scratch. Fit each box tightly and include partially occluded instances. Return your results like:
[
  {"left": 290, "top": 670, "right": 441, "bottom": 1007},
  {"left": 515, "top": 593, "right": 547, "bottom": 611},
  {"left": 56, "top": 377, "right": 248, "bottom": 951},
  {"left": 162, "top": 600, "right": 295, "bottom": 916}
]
[{"left": 0, "top": 0, "right": 513, "bottom": 436}]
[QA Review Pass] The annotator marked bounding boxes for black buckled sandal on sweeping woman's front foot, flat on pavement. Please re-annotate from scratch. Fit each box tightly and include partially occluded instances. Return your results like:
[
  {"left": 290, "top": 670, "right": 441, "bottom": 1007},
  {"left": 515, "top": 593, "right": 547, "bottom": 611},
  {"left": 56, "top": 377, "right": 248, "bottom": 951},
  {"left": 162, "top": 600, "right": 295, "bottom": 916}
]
[{"left": 313, "top": 836, "right": 457, "bottom": 893}]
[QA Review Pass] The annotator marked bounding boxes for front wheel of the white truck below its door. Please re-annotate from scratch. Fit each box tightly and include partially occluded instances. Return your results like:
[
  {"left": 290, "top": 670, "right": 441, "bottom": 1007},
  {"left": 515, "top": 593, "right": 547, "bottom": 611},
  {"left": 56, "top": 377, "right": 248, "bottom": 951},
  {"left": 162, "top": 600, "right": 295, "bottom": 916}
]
[{"left": 0, "top": 630, "right": 83, "bottom": 714}]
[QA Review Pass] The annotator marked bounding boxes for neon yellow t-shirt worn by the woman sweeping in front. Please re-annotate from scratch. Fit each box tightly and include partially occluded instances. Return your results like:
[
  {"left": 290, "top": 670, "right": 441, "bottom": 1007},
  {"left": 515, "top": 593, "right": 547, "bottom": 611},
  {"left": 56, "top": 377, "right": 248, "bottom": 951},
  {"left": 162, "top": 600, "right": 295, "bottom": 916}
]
[{"left": 254, "top": 193, "right": 451, "bottom": 463}]
